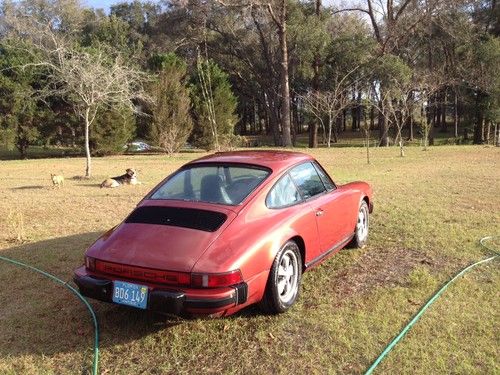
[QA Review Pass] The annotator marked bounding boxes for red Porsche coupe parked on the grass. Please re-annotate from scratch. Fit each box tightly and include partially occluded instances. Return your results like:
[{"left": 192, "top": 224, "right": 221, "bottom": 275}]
[{"left": 74, "top": 151, "right": 373, "bottom": 316}]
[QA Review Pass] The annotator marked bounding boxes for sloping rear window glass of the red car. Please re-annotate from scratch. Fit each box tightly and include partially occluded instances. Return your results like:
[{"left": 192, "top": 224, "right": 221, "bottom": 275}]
[{"left": 150, "top": 164, "right": 270, "bottom": 205}]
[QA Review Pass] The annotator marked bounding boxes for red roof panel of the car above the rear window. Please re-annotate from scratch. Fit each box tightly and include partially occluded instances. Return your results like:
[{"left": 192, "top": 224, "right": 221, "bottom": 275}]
[{"left": 188, "top": 150, "right": 314, "bottom": 172}]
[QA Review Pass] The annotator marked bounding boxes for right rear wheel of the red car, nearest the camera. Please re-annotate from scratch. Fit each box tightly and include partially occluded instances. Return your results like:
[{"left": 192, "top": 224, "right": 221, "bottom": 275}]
[{"left": 259, "top": 241, "right": 302, "bottom": 314}]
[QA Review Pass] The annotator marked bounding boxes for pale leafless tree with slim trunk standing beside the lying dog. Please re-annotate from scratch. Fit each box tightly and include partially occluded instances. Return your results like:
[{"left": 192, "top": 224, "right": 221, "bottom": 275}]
[{"left": 4, "top": 1, "right": 149, "bottom": 177}]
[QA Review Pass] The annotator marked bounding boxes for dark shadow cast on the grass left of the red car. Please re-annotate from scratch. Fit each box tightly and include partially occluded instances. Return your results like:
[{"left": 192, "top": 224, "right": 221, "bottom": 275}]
[{"left": 0, "top": 232, "right": 182, "bottom": 362}]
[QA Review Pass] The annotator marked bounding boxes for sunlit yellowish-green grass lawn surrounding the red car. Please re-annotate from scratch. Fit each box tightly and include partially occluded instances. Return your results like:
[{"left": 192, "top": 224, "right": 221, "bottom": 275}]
[{"left": 0, "top": 146, "right": 500, "bottom": 374}]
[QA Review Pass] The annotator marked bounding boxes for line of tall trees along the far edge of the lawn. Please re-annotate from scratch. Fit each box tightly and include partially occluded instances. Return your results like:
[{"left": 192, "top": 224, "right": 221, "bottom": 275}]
[{"left": 0, "top": 0, "right": 500, "bottom": 174}]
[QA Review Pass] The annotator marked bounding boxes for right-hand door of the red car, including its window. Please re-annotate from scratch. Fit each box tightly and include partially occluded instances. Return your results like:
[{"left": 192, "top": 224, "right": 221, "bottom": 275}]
[{"left": 290, "top": 162, "right": 348, "bottom": 253}]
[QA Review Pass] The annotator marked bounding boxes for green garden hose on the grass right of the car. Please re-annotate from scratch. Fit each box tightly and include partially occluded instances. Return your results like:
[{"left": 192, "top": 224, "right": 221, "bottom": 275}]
[{"left": 365, "top": 236, "right": 500, "bottom": 375}]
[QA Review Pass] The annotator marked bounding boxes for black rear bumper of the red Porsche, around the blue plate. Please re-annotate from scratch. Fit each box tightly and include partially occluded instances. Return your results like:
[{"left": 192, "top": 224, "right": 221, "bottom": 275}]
[{"left": 73, "top": 267, "right": 248, "bottom": 315}]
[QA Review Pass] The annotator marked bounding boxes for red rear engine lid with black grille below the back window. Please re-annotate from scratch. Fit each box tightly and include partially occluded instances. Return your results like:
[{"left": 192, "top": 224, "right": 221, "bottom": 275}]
[{"left": 87, "top": 201, "right": 236, "bottom": 272}]
